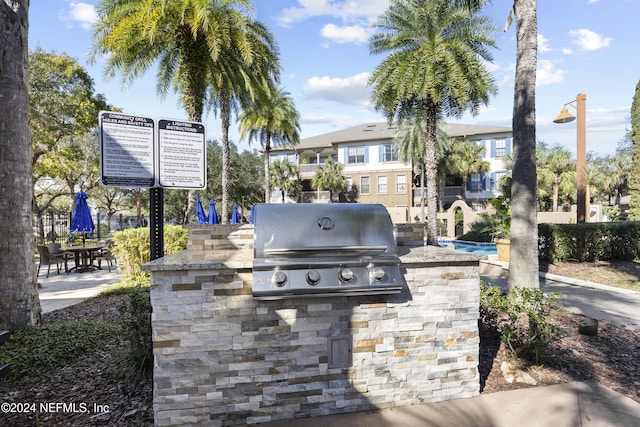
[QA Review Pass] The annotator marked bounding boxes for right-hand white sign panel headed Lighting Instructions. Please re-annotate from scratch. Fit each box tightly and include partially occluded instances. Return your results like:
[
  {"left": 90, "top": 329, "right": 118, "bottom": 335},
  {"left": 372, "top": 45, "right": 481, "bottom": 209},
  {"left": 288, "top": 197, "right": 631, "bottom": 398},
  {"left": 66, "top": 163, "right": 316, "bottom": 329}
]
[{"left": 158, "top": 119, "right": 207, "bottom": 190}]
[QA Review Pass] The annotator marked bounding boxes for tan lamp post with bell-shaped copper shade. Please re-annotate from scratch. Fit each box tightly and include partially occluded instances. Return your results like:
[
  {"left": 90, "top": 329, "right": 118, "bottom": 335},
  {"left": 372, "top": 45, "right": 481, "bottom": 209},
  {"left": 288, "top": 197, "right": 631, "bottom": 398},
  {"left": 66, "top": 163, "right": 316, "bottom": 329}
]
[{"left": 553, "top": 93, "right": 587, "bottom": 222}]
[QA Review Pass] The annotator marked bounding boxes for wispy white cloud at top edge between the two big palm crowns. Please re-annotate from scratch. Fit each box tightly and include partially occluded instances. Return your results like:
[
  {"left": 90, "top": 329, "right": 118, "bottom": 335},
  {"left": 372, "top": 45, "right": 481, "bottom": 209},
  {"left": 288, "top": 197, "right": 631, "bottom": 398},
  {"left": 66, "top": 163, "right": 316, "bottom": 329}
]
[{"left": 278, "top": 0, "right": 389, "bottom": 27}]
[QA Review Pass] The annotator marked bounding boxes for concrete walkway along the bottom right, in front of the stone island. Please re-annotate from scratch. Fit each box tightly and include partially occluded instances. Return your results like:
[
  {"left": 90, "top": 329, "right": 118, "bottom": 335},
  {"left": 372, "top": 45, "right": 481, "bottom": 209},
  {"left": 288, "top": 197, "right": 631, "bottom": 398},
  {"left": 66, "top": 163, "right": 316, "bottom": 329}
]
[{"left": 259, "top": 382, "right": 640, "bottom": 427}]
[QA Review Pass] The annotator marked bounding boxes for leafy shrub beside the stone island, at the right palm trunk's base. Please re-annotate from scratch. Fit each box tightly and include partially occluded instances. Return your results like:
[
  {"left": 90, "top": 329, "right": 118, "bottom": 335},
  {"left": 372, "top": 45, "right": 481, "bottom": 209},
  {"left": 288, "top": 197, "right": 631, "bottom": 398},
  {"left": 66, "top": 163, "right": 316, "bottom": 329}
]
[{"left": 480, "top": 284, "right": 561, "bottom": 363}]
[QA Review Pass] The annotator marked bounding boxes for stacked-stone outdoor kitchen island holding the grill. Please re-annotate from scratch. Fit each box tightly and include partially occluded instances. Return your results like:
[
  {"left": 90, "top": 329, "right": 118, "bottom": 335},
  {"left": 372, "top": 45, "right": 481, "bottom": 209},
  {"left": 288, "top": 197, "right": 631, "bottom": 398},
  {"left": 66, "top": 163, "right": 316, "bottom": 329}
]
[{"left": 144, "top": 224, "right": 480, "bottom": 426}]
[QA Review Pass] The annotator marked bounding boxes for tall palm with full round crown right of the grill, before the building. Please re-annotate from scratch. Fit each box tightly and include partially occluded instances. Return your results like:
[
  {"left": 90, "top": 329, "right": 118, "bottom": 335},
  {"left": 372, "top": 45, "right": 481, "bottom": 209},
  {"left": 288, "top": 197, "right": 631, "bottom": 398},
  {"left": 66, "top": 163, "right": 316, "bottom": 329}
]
[{"left": 369, "top": 0, "right": 496, "bottom": 245}]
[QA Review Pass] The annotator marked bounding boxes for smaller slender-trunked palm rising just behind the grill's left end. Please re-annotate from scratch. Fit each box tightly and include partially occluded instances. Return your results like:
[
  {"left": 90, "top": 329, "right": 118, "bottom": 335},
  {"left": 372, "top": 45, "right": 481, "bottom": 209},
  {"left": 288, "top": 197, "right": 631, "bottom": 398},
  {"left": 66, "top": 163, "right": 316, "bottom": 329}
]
[{"left": 239, "top": 82, "right": 300, "bottom": 203}]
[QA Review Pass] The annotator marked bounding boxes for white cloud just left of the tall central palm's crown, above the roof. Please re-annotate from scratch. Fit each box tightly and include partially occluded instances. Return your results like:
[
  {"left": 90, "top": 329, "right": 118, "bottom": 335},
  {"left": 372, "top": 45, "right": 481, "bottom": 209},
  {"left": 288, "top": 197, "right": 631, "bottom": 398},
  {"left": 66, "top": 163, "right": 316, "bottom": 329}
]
[{"left": 304, "top": 73, "right": 371, "bottom": 105}]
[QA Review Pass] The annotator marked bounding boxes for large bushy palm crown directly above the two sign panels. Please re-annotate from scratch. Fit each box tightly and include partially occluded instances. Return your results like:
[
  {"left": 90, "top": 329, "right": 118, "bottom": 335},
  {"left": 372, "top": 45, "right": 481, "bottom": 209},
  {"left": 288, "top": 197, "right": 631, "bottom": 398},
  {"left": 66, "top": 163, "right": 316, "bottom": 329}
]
[{"left": 91, "top": 0, "right": 277, "bottom": 224}]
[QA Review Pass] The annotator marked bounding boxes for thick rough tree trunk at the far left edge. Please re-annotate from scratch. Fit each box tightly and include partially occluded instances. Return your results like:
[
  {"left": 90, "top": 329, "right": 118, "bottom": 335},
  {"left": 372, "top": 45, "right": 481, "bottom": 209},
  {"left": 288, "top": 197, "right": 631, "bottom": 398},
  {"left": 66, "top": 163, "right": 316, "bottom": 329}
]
[{"left": 0, "top": 0, "right": 41, "bottom": 330}]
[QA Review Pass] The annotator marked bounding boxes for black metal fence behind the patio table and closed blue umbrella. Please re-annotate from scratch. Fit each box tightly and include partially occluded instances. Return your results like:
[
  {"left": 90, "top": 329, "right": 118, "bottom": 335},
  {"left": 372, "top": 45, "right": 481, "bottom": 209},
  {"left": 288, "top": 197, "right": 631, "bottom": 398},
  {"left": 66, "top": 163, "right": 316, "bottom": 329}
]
[{"left": 33, "top": 212, "right": 147, "bottom": 244}]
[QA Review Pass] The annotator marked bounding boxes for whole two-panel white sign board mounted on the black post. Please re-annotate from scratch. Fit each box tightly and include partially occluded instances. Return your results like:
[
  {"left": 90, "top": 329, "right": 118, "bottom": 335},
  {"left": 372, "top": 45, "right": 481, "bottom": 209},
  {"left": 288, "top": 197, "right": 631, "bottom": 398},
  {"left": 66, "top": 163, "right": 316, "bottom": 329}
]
[{"left": 99, "top": 111, "right": 207, "bottom": 190}]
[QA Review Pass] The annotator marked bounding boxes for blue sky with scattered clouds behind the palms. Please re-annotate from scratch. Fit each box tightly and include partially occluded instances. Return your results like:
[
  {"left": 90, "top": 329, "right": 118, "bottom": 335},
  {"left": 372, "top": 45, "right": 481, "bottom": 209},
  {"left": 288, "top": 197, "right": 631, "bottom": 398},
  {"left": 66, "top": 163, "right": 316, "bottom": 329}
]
[{"left": 29, "top": 0, "right": 640, "bottom": 157}]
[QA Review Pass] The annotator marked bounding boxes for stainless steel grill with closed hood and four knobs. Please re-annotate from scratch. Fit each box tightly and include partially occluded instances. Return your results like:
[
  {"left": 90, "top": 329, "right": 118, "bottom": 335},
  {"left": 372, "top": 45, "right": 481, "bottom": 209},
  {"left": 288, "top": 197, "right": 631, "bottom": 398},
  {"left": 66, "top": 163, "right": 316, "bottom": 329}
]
[{"left": 252, "top": 204, "right": 403, "bottom": 299}]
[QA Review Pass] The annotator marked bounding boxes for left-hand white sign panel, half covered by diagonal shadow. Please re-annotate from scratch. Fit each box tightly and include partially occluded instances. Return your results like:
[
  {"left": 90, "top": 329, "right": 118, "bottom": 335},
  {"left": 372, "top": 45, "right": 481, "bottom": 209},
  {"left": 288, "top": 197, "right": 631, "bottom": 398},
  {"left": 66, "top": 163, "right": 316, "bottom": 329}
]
[{"left": 99, "top": 111, "right": 156, "bottom": 187}]
